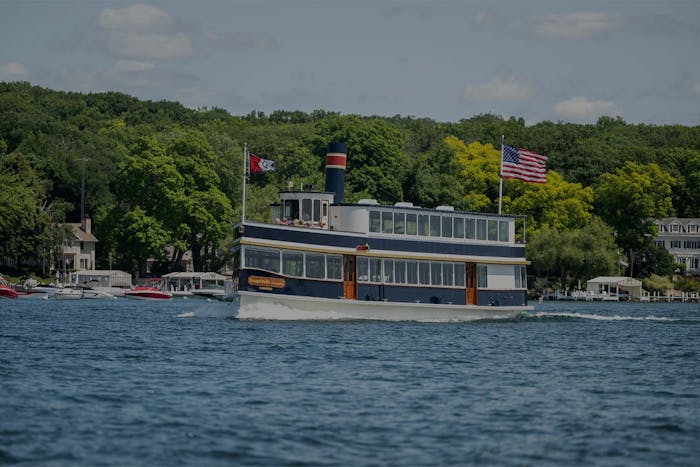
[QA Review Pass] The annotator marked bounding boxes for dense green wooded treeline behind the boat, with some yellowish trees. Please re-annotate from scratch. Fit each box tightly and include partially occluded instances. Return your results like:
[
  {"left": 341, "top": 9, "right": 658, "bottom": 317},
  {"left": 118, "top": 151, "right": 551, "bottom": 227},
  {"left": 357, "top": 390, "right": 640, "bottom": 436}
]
[{"left": 0, "top": 82, "right": 700, "bottom": 288}]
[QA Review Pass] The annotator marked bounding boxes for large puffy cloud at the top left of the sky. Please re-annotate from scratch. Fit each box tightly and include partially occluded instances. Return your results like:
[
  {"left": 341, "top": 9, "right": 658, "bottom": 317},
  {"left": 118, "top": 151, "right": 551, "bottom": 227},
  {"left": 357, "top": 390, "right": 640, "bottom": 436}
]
[{"left": 97, "top": 4, "right": 195, "bottom": 60}]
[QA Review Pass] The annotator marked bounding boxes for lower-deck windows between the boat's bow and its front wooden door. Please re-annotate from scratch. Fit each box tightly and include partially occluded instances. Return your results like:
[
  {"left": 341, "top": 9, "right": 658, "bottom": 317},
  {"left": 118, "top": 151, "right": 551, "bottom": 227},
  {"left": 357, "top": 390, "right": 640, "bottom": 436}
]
[{"left": 244, "top": 247, "right": 343, "bottom": 280}]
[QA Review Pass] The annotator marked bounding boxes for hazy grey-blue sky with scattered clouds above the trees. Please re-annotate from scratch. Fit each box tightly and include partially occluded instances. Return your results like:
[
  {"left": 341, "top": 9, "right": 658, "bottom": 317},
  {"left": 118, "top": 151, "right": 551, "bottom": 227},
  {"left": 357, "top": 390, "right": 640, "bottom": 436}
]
[{"left": 0, "top": 0, "right": 700, "bottom": 126}]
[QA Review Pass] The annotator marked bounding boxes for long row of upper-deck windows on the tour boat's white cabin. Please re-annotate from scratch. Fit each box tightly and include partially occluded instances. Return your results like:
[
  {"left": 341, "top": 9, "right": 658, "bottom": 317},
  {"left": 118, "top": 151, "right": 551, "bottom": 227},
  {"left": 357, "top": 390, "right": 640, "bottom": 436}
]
[{"left": 369, "top": 211, "right": 510, "bottom": 242}]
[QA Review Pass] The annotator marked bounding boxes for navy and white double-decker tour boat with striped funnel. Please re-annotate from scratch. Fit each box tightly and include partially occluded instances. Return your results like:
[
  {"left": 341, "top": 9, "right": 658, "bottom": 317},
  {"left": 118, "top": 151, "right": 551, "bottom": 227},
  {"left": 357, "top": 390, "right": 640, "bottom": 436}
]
[{"left": 230, "top": 143, "right": 532, "bottom": 321}]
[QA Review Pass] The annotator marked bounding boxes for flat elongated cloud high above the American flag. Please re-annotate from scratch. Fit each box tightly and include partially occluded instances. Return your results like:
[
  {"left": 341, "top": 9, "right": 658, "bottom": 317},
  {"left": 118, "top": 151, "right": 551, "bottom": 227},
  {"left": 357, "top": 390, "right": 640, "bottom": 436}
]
[{"left": 531, "top": 13, "right": 623, "bottom": 39}]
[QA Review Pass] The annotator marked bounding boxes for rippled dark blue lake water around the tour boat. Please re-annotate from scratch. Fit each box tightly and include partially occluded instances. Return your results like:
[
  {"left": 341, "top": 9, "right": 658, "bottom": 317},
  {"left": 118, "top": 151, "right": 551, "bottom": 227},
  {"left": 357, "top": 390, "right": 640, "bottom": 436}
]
[{"left": 0, "top": 299, "right": 700, "bottom": 466}]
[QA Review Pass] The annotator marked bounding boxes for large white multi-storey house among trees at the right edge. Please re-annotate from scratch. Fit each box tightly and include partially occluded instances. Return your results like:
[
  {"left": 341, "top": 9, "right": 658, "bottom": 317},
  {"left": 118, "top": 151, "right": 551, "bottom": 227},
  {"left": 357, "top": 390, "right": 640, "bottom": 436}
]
[{"left": 654, "top": 217, "right": 700, "bottom": 276}]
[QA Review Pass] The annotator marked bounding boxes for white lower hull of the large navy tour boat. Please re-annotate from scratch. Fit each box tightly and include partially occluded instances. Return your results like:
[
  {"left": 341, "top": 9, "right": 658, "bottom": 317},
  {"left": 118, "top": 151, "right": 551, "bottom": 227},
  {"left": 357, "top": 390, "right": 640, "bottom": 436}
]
[{"left": 232, "top": 291, "right": 533, "bottom": 322}]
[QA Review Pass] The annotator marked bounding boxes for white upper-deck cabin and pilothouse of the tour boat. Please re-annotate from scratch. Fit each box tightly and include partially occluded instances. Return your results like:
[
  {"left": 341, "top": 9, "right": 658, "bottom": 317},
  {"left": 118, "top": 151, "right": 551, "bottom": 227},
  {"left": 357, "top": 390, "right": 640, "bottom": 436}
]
[{"left": 272, "top": 191, "right": 524, "bottom": 246}]
